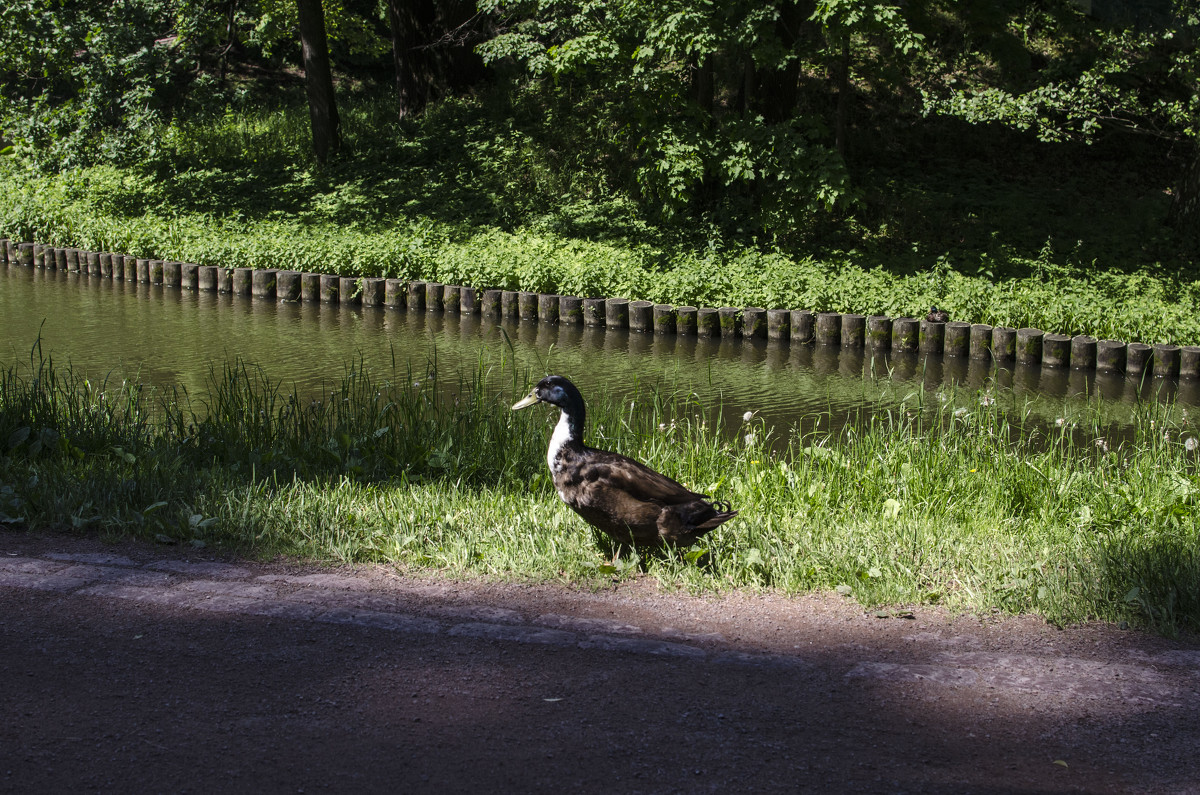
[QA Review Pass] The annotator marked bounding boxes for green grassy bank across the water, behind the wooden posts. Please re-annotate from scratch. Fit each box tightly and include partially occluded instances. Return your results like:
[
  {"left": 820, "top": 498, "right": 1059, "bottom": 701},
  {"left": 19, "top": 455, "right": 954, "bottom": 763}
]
[{"left": 0, "top": 90, "right": 1200, "bottom": 345}]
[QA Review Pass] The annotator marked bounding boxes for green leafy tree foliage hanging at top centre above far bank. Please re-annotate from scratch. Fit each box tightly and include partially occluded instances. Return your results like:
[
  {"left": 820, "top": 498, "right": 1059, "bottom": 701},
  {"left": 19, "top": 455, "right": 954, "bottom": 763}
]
[{"left": 479, "top": 0, "right": 850, "bottom": 235}]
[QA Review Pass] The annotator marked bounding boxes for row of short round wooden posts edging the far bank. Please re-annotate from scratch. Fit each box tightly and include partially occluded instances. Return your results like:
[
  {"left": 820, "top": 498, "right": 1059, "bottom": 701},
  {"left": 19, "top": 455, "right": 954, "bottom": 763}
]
[{"left": 9, "top": 239, "right": 1200, "bottom": 378}]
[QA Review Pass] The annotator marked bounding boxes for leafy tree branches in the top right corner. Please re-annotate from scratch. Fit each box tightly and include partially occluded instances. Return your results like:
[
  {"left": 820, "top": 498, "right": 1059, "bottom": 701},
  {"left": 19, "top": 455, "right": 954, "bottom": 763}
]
[{"left": 924, "top": 0, "right": 1200, "bottom": 245}]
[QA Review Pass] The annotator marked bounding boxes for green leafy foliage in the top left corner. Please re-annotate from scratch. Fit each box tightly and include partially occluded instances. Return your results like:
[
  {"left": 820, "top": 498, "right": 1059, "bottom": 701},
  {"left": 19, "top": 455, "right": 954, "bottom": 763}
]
[{"left": 0, "top": 0, "right": 390, "bottom": 168}]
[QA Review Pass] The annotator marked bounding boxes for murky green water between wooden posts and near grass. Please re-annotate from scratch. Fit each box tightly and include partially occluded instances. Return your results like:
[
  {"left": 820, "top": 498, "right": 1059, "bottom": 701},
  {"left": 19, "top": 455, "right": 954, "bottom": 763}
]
[{"left": 0, "top": 267, "right": 1200, "bottom": 439}]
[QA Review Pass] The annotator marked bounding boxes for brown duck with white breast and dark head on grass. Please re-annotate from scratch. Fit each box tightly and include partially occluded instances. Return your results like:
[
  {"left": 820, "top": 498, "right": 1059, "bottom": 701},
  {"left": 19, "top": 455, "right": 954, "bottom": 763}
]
[{"left": 512, "top": 376, "right": 738, "bottom": 548}]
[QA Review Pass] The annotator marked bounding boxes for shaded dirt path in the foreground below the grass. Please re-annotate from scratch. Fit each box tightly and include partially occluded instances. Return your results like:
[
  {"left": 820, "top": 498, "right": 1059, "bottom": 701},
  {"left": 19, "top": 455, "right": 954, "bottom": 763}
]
[{"left": 0, "top": 532, "right": 1200, "bottom": 793}]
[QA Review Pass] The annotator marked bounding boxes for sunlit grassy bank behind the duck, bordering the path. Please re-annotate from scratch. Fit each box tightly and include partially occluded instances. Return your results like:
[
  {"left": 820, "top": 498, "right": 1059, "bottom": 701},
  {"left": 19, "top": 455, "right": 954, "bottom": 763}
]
[{"left": 0, "top": 355, "right": 1200, "bottom": 632}]
